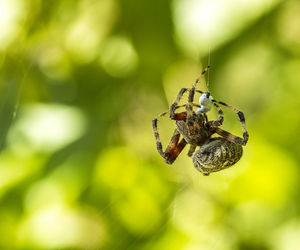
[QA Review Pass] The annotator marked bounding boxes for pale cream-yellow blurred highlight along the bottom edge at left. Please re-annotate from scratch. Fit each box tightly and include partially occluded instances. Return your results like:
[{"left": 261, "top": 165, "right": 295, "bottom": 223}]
[{"left": 19, "top": 206, "right": 105, "bottom": 248}]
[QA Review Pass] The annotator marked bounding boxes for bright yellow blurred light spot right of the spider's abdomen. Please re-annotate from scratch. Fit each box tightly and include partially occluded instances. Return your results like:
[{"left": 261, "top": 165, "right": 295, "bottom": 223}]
[{"left": 229, "top": 141, "right": 297, "bottom": 208}]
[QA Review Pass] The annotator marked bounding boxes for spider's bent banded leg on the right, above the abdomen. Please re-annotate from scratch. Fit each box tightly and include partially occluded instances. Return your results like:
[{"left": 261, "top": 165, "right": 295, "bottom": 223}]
[{"left": 213, "top": 100, "right": 249, "bottom": 146}]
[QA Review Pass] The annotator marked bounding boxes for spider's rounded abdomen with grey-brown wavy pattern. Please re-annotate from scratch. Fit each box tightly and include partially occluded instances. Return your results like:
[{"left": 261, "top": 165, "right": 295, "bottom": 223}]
[{"left": 193, "top": 137, "right": 243, "bottom": 175}]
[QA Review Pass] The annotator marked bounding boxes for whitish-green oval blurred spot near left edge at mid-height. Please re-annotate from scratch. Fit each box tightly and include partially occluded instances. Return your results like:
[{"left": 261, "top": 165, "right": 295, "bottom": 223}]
[{"left": 9, "top": 104, "right": 86, "bottom": 151}]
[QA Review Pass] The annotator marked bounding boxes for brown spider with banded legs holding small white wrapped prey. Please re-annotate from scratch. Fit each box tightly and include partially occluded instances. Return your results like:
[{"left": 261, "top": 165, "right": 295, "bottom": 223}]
[{"left": 152, "top": 66, "right": 249, "bottom": 175}]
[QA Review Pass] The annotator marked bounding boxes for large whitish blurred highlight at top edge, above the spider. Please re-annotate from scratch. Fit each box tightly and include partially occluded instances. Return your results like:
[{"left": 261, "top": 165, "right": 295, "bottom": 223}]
[{"left": 173, "top": 0, "right": 279, "bottom": 57}]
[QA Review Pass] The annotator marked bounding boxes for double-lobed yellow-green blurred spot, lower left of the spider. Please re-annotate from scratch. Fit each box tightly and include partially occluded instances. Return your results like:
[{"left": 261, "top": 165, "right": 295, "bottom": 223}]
[{"left": 95, "top": 147, "right": 168, "bottom": 235}]
